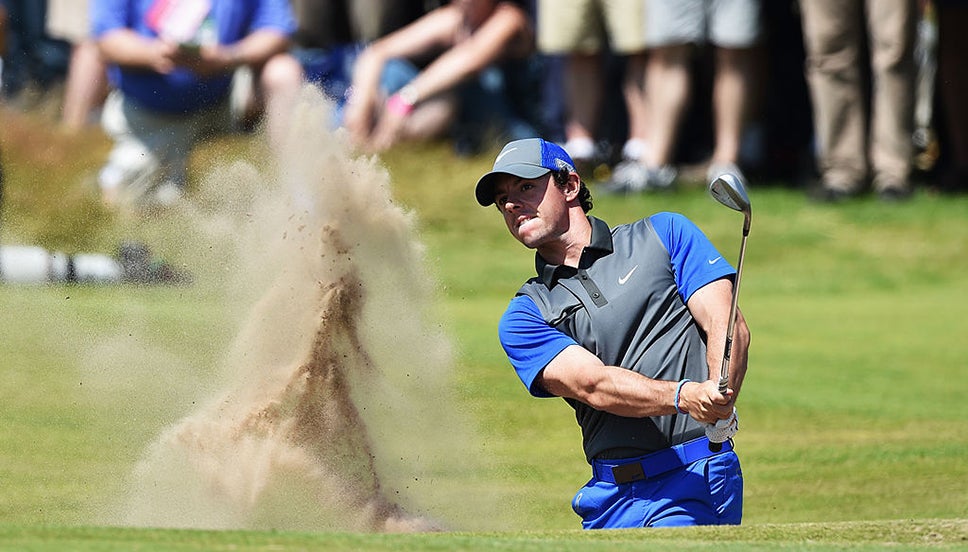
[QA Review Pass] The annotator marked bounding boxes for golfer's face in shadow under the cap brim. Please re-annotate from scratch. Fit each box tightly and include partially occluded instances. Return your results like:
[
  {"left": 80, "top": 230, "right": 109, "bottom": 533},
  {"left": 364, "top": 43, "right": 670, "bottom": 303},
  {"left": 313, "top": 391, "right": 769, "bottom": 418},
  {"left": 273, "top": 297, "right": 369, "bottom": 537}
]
[{"left": 494, "top": 172, "right": 568, "bottom": 249}]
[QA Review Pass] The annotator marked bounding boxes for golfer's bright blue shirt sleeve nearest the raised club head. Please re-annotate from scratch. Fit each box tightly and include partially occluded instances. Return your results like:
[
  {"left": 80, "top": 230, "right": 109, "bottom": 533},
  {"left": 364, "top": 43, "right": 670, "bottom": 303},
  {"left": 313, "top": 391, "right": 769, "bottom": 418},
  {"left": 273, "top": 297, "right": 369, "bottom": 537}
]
[{"left": 649, "top": 213, "right": 736, "bottom": 303}]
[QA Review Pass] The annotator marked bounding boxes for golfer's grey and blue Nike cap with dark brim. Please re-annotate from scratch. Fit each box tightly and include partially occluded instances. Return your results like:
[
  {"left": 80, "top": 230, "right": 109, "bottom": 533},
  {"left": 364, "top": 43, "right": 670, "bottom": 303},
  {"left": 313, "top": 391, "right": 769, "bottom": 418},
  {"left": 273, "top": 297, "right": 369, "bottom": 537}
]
[{"left": 474, "top": 138, "right": 575, "bottom": 207}]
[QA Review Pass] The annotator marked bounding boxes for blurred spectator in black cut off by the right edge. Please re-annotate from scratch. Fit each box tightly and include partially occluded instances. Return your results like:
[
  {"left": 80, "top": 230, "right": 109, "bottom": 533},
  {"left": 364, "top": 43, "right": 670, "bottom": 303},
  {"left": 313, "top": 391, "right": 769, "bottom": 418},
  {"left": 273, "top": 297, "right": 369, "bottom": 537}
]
[{"left": 934, "top": 0, "right": 968, "bottom": 192}]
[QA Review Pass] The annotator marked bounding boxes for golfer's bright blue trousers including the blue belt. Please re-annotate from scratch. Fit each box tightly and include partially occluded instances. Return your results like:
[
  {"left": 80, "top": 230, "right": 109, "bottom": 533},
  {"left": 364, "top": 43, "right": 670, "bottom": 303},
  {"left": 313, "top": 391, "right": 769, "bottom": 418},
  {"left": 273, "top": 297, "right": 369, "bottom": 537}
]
[{"left": 572, "top": 437, "right": 743, "bottom": 529}]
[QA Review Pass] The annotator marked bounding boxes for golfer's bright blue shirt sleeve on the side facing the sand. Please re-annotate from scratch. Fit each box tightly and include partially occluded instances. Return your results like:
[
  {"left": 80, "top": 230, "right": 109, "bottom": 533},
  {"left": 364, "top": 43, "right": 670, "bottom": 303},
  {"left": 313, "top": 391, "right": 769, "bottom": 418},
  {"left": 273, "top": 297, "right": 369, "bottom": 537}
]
[{"left": 498, "top": 295, "right": 577, "bottom": 397}]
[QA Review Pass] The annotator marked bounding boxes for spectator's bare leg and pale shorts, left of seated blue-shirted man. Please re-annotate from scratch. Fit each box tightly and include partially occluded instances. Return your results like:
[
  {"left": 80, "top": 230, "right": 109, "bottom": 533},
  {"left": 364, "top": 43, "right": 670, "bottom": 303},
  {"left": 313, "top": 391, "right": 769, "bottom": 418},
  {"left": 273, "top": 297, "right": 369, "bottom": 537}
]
[{"left": 47, "top": 0, "right": 108, "bottom": 130}]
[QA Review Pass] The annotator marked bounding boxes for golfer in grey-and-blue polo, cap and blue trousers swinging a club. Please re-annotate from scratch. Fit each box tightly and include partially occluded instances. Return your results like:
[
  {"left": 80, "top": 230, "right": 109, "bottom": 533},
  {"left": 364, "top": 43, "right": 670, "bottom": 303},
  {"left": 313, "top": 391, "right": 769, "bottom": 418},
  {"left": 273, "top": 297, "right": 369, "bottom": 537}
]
[{"left": 476, "top": 139, "right": 750, "bottom": 529}]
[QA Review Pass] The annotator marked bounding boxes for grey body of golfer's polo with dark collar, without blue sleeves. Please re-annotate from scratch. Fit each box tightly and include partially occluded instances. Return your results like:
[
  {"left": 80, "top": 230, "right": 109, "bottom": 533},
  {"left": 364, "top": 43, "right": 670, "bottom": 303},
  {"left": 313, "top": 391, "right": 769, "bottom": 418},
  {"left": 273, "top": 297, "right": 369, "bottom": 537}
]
[{"left": 518, "top": 217, "right": 709, "bottom": 461}]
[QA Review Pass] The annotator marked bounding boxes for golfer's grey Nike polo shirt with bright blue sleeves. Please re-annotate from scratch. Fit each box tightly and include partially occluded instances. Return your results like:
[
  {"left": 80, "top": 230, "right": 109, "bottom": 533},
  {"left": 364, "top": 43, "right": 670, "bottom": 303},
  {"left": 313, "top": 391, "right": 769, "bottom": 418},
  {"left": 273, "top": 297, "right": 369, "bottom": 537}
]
[{"left": 498, "top": 213, "right": 736, "bottom": 461}]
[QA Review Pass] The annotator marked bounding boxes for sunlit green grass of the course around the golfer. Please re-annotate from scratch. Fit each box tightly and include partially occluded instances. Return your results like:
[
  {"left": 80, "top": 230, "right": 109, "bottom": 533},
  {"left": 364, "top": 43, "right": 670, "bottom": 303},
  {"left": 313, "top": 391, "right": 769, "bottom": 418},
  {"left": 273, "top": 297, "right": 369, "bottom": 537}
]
[{"left": 0, "top": 104, "right": 968, "bottom": 552}]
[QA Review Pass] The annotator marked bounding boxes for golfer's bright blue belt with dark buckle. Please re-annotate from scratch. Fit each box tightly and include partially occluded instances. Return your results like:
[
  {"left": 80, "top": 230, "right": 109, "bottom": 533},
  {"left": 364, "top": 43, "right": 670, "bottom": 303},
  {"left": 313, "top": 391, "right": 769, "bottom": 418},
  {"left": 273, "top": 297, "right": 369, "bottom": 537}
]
[{"left": 592, "top": 437, "right": 733, "bottom": 485}]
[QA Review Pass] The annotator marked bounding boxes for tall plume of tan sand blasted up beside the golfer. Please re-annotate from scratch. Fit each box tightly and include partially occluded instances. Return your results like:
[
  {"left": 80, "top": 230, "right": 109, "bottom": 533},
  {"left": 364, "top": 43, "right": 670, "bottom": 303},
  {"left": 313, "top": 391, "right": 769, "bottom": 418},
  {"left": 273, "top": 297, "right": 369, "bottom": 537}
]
[{"left": 86, "top": 87, "right": 497, "bottom": 531}]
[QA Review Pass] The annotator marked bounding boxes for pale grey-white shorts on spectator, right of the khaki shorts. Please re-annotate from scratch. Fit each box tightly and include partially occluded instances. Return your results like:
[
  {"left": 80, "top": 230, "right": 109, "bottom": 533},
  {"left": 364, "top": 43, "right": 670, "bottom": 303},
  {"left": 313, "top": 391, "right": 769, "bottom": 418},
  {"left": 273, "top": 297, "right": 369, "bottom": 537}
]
[{"left": 645, "top": 0, "right": 761, "bottom": 48}]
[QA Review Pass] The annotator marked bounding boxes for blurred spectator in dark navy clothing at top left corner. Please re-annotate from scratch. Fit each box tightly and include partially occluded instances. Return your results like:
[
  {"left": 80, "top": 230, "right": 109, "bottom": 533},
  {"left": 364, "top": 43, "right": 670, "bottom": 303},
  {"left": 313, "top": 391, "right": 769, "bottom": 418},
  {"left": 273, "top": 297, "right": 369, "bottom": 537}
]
[{"left": 0, "top": 0, "right": 70, "bottom": 102}]
